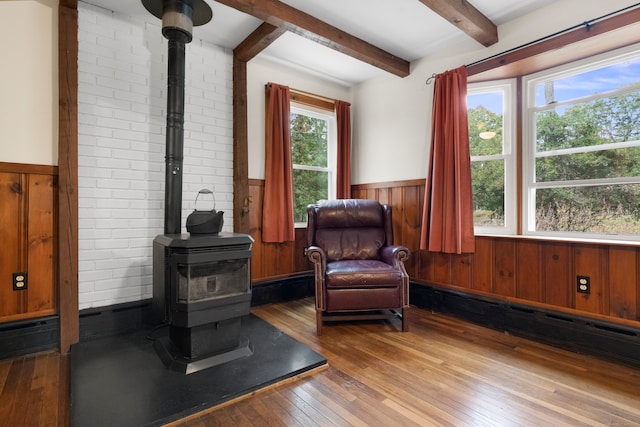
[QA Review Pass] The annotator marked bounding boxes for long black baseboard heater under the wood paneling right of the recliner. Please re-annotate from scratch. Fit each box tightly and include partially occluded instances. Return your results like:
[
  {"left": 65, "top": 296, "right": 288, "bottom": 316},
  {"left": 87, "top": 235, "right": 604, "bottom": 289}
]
[{"left": 410, "top": 283, "right": 640, "bottom": 368}]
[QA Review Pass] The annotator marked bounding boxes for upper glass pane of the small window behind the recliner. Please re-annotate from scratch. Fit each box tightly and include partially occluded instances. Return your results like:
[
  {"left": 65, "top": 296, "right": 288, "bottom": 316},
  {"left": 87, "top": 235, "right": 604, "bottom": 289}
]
[{"left": 291, "top": 113, "right": 328, "bottom": 167}]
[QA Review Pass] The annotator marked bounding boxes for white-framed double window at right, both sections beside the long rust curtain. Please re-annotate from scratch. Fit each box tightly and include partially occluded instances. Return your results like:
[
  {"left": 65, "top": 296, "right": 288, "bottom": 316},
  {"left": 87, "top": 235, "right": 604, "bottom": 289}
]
[{"left": 467, "top": 45, "right": 640, "bottom": 244}]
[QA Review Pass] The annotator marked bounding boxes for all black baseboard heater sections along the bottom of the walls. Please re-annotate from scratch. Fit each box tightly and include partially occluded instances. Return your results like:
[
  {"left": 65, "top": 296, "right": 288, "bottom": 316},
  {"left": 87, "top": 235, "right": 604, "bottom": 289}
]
[{"left": 0, "top": 276, "right": 640, "bottom": 368}]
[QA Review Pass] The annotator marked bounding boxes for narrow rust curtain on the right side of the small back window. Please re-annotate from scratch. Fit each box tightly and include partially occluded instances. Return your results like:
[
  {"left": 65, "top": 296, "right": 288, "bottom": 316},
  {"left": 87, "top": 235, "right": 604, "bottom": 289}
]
[{"left": 335, "top": 101, "right": 351, "bottom": 199}]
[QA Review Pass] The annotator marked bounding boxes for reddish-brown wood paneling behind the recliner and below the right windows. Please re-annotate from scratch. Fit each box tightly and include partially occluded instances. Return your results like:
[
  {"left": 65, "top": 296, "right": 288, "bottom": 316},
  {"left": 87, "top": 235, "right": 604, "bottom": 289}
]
[{"left": 250, "top": 180, "right": 640, "bottom": 327}]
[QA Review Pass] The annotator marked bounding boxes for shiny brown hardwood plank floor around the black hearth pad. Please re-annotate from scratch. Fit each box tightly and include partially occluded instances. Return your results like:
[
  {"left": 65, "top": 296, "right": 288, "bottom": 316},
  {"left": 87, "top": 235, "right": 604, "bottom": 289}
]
[{"left": 0, "top": 299, "right": 640, "bottom": 427}]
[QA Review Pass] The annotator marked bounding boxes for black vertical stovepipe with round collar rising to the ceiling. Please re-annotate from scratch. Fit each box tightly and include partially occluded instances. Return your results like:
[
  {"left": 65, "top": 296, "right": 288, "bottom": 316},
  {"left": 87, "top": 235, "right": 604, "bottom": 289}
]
[{"left": 142, "top": 0, "right": 212, "bottom": 234}]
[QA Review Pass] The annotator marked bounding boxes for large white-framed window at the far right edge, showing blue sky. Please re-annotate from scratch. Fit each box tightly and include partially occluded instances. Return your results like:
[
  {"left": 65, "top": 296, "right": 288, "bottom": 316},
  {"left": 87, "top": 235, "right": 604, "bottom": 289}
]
[{"left": 523, "top": 47, "right": 640, "bottom": 239}]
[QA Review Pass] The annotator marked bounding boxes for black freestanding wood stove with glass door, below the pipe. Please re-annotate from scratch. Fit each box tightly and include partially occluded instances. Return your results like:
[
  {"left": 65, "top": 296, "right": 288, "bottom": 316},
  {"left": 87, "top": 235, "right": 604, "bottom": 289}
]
[{"left": 152, "top": 233, "right": 253, "bottom": 373}]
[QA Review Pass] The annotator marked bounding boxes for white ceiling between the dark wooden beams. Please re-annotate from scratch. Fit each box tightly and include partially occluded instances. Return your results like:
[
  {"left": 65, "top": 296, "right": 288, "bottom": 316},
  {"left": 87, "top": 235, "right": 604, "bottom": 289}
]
[{"left": 81, "top": 0, "right": 556, "bottom": 86}]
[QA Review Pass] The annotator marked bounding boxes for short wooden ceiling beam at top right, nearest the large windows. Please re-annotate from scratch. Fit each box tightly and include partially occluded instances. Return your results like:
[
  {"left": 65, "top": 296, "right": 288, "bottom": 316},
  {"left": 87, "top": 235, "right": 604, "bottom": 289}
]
[{"left": 420, "top": 0, "right": 498, "bottom": 47}]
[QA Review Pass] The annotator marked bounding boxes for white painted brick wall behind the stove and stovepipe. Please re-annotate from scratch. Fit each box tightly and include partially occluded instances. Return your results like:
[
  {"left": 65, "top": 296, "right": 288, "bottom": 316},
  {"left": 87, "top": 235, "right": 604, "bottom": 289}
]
[{"left": 78, "top": 2, "right": 233, "bottom": 309}]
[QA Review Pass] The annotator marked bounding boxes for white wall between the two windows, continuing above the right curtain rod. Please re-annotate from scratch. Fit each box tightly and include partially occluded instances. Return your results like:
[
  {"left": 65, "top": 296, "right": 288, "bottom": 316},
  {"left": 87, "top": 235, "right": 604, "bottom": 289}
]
[{"left": 352, "top": 0, "right": 636, "bottom": 184}]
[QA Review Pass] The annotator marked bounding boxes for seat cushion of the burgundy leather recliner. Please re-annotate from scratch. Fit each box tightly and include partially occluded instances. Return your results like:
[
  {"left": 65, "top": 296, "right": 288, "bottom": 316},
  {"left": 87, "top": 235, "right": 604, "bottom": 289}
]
[{"left": 325, "top": 260, "right": 402, "bottom": 289}]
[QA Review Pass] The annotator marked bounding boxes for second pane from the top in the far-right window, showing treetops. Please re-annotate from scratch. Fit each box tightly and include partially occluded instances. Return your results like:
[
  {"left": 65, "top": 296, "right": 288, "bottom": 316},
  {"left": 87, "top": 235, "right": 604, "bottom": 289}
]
[{"left": 535, "top": 92, "right": 640, "bottom": 152}]
